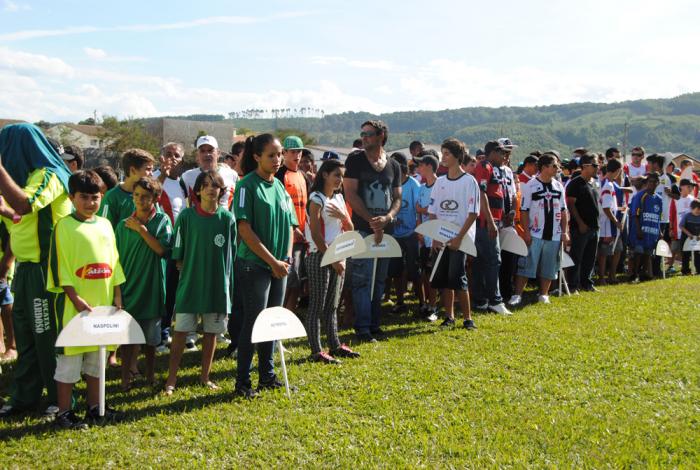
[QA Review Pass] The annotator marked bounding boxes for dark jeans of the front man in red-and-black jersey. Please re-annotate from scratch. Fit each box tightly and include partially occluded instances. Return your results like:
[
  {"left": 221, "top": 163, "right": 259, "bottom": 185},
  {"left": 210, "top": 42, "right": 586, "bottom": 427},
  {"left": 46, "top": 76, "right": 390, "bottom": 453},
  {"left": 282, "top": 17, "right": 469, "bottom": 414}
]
[{"left": 472, "top": 226, "right": 503, "bottom": 305}]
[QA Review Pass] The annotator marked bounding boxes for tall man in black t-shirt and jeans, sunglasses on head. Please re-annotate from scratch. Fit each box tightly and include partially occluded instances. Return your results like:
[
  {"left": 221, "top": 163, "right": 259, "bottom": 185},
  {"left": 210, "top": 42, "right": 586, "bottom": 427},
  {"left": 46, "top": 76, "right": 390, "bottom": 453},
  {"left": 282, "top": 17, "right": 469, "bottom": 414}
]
[{"left": 343, "top": 121, "right": 401, "bottom": 342}]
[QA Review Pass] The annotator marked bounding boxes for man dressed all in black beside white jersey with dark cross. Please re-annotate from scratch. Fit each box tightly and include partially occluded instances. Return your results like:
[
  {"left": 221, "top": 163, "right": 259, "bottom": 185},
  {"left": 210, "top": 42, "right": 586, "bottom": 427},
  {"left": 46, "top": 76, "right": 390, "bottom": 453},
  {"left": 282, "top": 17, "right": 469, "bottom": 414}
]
[{"left": 566, "top": 154, "right": 600, "bottom": 292}]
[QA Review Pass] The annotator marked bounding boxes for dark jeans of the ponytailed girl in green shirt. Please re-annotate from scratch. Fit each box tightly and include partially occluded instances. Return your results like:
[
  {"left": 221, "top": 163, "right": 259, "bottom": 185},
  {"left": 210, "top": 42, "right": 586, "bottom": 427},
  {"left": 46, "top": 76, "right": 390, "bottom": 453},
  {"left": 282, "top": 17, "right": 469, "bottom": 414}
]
[{"left": 235, "top": 258, "right": 287, "bottom": 387}]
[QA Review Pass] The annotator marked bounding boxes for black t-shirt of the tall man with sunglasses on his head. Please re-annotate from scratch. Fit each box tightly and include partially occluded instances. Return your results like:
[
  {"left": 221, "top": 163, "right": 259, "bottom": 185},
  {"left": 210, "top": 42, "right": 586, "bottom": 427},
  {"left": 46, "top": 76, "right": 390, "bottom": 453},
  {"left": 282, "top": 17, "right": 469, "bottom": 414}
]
[{"left": 345, "top": 151, "right": 401, "bottom": 233}]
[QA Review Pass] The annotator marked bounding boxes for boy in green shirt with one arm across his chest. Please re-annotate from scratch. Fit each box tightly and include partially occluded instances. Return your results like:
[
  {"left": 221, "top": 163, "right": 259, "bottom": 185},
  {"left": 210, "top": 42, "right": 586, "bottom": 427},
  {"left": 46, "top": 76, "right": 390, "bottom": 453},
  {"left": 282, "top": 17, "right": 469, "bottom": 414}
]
[{"left": 115, "top": 177, "right": 173, "bottom": 390}]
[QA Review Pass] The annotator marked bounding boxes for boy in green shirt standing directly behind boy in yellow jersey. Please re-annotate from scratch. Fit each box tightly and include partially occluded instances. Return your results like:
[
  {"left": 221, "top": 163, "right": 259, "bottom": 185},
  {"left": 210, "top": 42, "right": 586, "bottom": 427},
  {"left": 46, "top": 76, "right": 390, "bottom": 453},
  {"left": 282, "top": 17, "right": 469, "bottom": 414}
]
[{"left": 99, "top": 149, "right": 156, "bottom": 228}]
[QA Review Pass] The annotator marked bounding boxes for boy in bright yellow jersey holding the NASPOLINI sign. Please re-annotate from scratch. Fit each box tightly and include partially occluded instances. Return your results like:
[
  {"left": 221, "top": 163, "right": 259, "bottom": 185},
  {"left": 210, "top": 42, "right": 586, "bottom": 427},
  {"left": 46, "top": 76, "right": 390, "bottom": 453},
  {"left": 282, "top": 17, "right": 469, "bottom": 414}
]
[{"left": 47, "top": 170, "right": 125, "bottom": 429}]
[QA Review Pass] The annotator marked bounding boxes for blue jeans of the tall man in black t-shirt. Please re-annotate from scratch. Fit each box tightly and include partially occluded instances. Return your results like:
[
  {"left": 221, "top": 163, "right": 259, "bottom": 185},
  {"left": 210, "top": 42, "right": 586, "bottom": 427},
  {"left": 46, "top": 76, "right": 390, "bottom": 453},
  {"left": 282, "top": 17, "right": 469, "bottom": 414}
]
[{"left": 348, "top": 232, "right": 390, "bottom": 334}]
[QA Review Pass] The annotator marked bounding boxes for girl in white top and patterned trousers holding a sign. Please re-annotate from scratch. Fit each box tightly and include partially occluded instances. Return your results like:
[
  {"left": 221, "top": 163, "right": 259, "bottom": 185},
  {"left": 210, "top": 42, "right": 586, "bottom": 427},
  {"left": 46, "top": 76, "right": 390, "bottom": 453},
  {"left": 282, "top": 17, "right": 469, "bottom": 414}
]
[{"left": 305, "top": 160, "right": 359, "bottom": 364}]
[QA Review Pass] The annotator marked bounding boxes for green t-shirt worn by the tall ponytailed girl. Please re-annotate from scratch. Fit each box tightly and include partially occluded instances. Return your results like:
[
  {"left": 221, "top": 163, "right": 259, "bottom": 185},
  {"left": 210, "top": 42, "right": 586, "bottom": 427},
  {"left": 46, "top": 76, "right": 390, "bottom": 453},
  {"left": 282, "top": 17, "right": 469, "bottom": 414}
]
[{"left": 233, "top": 172, "right": 297, "bottom": 269}]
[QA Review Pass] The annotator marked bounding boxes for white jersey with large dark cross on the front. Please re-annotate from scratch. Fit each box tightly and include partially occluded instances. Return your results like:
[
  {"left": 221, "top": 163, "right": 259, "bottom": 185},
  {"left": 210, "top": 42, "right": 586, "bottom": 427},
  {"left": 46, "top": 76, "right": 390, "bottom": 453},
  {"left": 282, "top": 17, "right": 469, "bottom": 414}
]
[{"left": 520, "top": 177, "right": 566, "bottom": 241}]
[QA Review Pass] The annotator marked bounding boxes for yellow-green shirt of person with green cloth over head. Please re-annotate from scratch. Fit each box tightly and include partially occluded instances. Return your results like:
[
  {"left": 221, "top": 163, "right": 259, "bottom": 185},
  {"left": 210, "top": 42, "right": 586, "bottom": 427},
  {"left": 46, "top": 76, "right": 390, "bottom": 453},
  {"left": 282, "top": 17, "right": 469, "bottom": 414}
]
[{"left": 9, "top": 168, "right": 73, "bottom": 263}]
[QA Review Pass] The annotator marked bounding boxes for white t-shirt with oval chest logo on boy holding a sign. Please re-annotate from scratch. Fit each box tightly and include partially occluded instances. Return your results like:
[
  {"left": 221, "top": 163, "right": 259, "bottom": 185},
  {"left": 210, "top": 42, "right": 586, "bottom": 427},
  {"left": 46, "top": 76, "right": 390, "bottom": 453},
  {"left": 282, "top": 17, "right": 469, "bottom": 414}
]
[{"left": 428, "top": 173, "right": 481, "bottom": 240}]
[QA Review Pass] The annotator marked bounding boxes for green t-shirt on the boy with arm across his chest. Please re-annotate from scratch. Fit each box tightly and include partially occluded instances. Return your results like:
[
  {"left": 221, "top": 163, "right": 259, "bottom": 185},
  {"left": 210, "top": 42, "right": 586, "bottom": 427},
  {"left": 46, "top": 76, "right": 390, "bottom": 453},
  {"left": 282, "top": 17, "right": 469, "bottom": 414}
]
[{"left": 114, "top": 212, "right": 173, "bottom": 320}]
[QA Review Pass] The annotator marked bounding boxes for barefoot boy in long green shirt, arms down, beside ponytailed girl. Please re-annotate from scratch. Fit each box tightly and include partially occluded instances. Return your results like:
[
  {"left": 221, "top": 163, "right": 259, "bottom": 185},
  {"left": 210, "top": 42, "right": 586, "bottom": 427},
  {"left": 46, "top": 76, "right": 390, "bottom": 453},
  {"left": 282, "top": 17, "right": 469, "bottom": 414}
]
[{"left": 165, "top": 170, "right": 236, "bottom": 395}]
